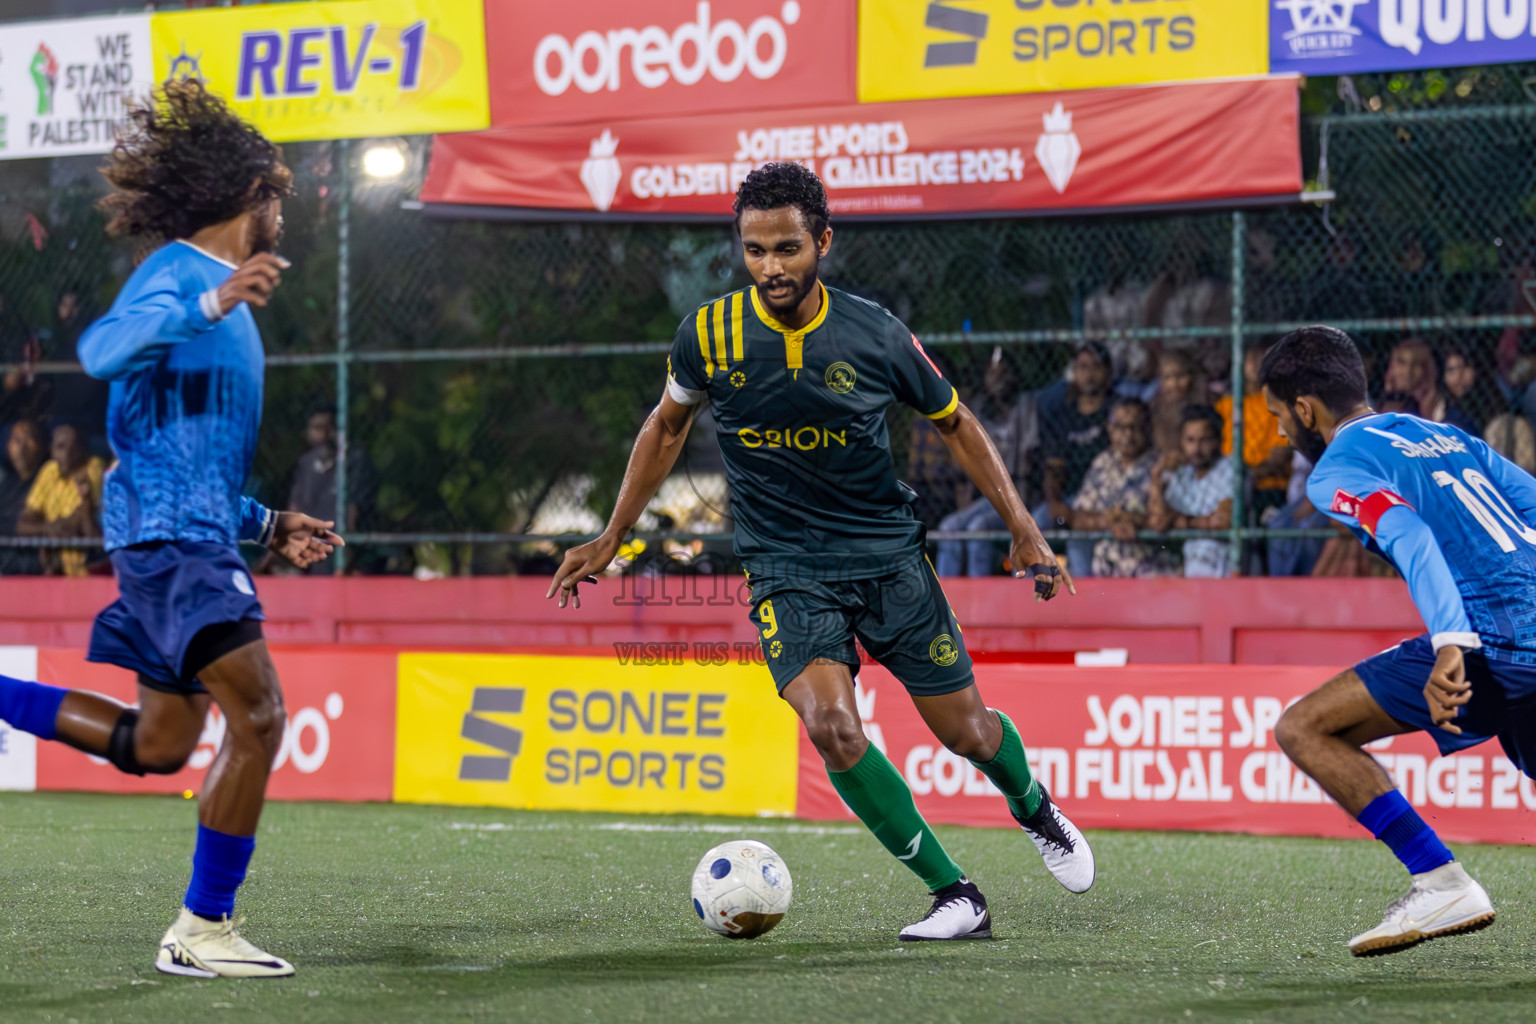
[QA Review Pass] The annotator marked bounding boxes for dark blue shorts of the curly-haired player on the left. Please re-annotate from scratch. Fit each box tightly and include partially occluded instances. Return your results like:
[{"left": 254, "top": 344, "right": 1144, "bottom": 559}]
[{"left": 86, "top": 540, "right": 266, "bottom": 694}]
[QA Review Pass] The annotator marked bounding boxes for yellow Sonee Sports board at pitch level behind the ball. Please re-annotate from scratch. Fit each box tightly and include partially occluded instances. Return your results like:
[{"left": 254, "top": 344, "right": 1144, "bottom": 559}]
[{"left": 395, "top": 654, "right": 799, "bottom": 815}]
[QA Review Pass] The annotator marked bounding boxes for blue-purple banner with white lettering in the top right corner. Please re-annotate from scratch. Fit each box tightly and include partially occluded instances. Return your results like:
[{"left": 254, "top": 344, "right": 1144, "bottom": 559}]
[{"left": 1269, "top": 0, "right": 1536, "bottom": 75}]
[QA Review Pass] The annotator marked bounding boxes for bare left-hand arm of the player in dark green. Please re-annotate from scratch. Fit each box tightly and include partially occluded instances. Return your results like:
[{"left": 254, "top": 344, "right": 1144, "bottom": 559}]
[{"left": 545, "top": 393, "right": 693, "bottom": 608}]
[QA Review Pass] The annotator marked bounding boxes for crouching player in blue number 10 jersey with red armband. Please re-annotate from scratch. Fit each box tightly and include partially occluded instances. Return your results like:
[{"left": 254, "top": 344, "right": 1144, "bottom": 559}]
[{"left": 1261, "top": 327, "right": 1536, "bottom": 956}]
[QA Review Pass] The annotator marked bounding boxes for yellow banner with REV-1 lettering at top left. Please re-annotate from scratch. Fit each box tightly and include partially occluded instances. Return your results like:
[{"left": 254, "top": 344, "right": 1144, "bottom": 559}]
[{"left": 151, "top": 0, "right": 490, "bottom": 141}]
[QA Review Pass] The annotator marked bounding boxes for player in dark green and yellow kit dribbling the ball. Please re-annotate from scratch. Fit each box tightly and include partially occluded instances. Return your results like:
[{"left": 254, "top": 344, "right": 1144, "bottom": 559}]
[{"left": 550, "top": 163, "right": 1094, "bottom": 940}]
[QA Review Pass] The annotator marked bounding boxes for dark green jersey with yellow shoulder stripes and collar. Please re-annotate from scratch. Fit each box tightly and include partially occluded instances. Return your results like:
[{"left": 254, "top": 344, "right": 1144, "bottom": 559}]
[{"left": 667, "top": 284, "right": 960, "bottom": 580}]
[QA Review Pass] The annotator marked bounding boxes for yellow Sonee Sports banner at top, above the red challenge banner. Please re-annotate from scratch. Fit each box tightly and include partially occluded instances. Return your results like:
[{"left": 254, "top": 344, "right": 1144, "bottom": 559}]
[{"left": 859, "top": 0, "right": 1269, "bottom": 103}]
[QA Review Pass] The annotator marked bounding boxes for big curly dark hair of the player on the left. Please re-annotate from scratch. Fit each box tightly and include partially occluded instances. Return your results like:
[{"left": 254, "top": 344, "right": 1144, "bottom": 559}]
[{"left": 101, "top": 80, "right": 293, "bottom": 246}]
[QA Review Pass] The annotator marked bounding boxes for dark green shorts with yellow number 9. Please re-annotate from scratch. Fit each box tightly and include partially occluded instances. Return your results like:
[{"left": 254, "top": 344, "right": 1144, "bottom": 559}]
[{"left": 751, "top": 559, "right": 972, "bottom": 697}]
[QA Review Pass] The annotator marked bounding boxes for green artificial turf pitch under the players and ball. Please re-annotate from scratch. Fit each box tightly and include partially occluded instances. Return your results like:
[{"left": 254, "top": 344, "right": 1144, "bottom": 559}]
[{"left": 0, "top": 794, "right": 1536, "bottom": 1024}]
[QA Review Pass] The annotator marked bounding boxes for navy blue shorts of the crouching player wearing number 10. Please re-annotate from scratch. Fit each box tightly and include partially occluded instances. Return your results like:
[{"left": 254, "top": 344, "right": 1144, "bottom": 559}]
[{"left": 1355, "top": 634, "right": 1536, "bottom": 778}]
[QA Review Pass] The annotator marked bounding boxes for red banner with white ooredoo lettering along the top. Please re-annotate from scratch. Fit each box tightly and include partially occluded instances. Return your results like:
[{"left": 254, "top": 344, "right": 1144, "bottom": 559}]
[{"left": 485, "top": 0, "right": 857, "bottom": 126}]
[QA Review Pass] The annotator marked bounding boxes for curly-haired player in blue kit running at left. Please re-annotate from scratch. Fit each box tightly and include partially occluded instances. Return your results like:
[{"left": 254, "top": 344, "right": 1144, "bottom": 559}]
[{"left": 0, "top": 81, "right": 341, "bottom": 978}]
